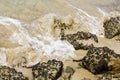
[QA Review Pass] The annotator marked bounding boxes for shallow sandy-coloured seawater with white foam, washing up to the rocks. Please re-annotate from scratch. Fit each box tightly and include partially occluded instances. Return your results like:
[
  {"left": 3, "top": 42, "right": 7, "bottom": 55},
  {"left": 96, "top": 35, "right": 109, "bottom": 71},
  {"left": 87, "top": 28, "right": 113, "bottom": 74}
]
[{"left": 0, "top": 0, "right": 120, "bottom": 79}]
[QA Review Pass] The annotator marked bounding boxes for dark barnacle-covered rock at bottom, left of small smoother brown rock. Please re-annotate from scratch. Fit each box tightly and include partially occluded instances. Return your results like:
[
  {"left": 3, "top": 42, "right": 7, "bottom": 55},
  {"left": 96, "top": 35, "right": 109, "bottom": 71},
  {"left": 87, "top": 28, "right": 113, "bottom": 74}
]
[{"left": 32, "top": 59, "right": 63, "bottom": 80}]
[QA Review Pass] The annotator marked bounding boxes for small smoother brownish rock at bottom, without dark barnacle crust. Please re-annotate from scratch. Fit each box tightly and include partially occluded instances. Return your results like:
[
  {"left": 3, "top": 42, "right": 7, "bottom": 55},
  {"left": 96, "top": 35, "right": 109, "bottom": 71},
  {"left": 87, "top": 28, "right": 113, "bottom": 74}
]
[{"left": 59, "top": 66, "right": 75, "bottom": 80}]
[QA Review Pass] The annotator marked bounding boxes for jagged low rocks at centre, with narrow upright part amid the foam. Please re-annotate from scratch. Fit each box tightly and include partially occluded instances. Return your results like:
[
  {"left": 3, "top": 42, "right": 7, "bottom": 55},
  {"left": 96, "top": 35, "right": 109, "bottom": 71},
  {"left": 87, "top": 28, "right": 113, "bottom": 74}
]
[{"left": 53, "top": 19, "right": 98, "bottom": 50}]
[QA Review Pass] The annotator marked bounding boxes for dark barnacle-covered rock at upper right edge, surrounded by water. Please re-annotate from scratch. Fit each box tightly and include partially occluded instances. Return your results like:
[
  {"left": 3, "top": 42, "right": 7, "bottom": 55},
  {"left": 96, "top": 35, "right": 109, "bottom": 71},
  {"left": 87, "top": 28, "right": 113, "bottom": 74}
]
[{"left": 103, "top": 16, "right": 120, "bottom": 39}]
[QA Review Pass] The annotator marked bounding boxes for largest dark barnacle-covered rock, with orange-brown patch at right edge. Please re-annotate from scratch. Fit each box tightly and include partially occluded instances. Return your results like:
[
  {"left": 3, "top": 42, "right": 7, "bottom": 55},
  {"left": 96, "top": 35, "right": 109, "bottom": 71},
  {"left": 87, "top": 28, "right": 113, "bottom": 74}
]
[{"left": 74, "top": 47, "right": 120, "bottom": 74}]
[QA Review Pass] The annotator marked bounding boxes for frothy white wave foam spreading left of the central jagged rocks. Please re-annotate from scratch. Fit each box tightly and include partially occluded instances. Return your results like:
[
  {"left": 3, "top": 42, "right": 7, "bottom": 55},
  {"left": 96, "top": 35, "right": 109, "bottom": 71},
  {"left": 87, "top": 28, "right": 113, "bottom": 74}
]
[{"left": 0, "top": 14, "right": 75, "bottom": 65}]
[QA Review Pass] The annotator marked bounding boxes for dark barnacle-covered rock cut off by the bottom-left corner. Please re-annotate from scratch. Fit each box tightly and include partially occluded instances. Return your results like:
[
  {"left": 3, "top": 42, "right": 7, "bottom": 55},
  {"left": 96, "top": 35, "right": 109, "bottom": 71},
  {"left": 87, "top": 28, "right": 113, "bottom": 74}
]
[{"left": 0, "top": 66, "right": 28, "bottom": 80}]
